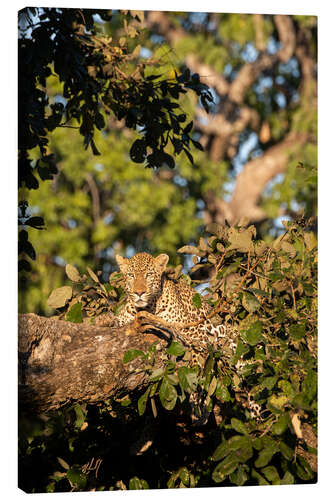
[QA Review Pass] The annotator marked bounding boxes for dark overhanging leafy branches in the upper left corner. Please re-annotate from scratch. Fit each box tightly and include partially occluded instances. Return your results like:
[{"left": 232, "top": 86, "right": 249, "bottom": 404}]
[{"left": 18, "top": 8, "right": 213, "bottom": 278}]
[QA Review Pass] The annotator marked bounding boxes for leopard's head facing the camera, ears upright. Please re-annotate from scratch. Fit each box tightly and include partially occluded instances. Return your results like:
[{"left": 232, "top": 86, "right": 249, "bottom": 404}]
[{"left": 116, "top": 253, "right": 169, "bottom": 309}]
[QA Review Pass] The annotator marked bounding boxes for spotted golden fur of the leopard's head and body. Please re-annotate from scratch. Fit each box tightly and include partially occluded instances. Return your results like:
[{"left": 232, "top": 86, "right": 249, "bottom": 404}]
[{"left": 111, "top": 253, "right": 231, "bottom": 360}]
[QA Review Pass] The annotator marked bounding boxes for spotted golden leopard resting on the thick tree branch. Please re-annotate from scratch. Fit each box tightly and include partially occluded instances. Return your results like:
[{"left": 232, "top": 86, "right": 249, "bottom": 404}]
[{"left": 97, "top": 252, "right": 259, "bottom": 417}]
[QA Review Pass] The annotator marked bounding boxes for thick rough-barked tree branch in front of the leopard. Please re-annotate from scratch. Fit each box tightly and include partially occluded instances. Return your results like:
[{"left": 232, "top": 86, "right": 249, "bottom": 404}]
[{"left": 18, "top": 314, "right": 166, "bottom": 412}]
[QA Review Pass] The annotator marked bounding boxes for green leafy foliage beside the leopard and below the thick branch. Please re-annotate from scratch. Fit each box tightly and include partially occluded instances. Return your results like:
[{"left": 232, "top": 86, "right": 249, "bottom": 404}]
[{"left": 20, "top": 221, "right": 317, "bottom": 491}]
